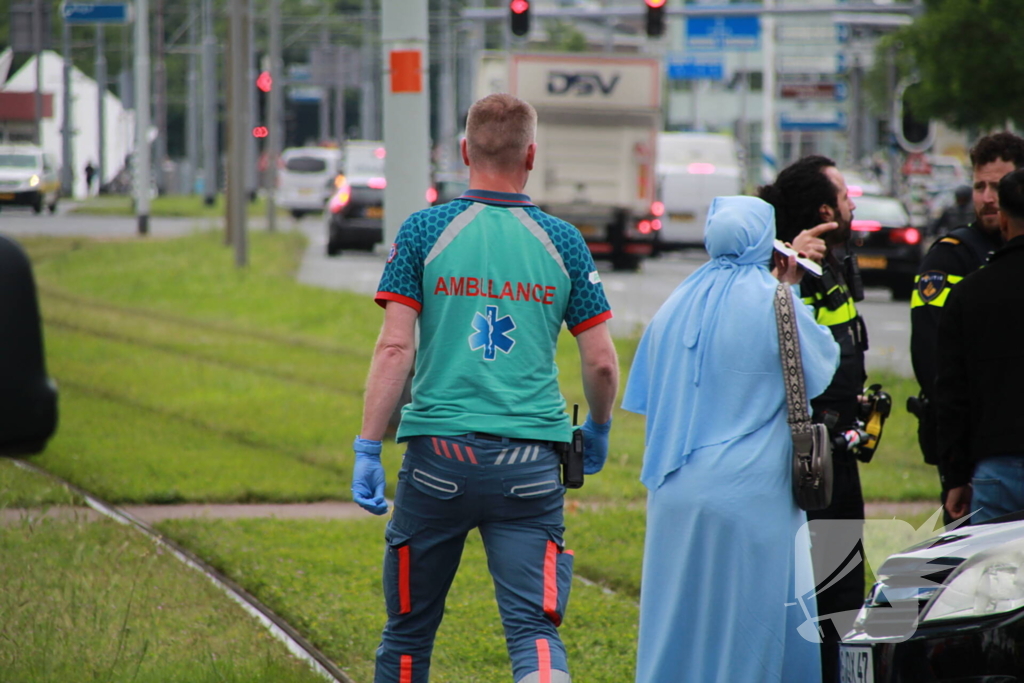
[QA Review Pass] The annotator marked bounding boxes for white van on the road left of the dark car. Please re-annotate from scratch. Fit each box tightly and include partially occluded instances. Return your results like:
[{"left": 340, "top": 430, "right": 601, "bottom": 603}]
[{"left": 278, "top": 147, "right": 341, "bottom": 218}]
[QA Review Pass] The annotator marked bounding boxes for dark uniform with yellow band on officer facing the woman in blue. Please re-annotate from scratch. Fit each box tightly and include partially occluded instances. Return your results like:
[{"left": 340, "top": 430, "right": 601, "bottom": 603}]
[{"left": 800, "top": 253, "right": 867, "bottom": 683}]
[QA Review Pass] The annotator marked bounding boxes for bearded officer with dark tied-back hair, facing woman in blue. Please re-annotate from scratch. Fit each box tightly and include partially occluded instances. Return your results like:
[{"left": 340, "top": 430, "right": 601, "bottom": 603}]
[{"left": 758, "top": 156, "right": 867, "bottom": 683}]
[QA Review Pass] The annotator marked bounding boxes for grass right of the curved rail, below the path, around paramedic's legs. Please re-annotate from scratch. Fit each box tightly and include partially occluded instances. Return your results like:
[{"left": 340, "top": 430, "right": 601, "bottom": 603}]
[{"left": 160, "top": 518, "right": 637, "bottom": 683}]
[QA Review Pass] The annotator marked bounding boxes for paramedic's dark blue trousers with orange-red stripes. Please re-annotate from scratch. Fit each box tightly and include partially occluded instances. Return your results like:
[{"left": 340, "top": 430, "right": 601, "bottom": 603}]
[{"left": 374, "top": 434, "right": 572, "bottom": 683}]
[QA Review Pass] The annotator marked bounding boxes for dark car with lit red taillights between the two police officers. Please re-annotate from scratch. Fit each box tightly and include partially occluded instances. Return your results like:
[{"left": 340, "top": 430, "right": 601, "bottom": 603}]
[{"left": 850, "top": 195, "right": 924, "bottom": 301}]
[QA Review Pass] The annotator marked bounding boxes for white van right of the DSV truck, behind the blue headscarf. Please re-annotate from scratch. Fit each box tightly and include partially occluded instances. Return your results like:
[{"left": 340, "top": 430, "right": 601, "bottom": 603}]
[{"left": 657, "top": 132, "right": 743, "bottom": 250}]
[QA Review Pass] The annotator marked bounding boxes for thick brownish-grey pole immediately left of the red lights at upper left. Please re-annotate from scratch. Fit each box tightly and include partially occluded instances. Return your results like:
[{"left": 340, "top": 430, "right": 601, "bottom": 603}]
[{"left": 227, "top": 0, "right": 252, "bottom": 268}]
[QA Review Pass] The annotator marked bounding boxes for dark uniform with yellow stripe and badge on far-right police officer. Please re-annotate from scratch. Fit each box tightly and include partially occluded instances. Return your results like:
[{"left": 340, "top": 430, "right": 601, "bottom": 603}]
[{"left": 910, "top": 221, "right": 1000, "bottom": 476}]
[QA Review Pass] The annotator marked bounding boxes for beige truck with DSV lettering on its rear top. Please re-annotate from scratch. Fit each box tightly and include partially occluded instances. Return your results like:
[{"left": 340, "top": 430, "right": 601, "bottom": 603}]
[{"left": 477, "top": 53, "right": 662, "bottom": 270}]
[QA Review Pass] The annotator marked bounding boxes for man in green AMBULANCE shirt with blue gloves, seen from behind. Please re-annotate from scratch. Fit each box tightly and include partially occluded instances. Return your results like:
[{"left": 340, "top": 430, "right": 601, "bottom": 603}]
[{"left": 352, "top": 94, "right": 618, "bottom": 683}]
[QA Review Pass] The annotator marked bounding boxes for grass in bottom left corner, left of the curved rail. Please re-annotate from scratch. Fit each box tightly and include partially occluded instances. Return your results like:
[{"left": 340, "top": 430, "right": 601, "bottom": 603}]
[{"left": 0, "top": 520, "right": 323, "bottom": 683}]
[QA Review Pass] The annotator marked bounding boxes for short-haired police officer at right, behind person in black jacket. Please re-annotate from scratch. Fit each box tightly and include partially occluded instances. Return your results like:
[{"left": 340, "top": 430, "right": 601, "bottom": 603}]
[{"left": 908, "top": 132, "right": 1024, "bottom": 523}]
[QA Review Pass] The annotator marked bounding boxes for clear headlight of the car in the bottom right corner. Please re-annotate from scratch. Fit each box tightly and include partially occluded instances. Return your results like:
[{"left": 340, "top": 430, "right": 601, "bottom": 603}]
[{"left": 921, "top": 541, "right": 1024, "bottom": 624}]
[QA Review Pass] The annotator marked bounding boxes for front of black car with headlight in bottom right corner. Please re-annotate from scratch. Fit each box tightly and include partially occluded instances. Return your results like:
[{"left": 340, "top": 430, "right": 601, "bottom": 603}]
[{"left": 840, "top": 513, "right": 1024, "bottom": 683}]
